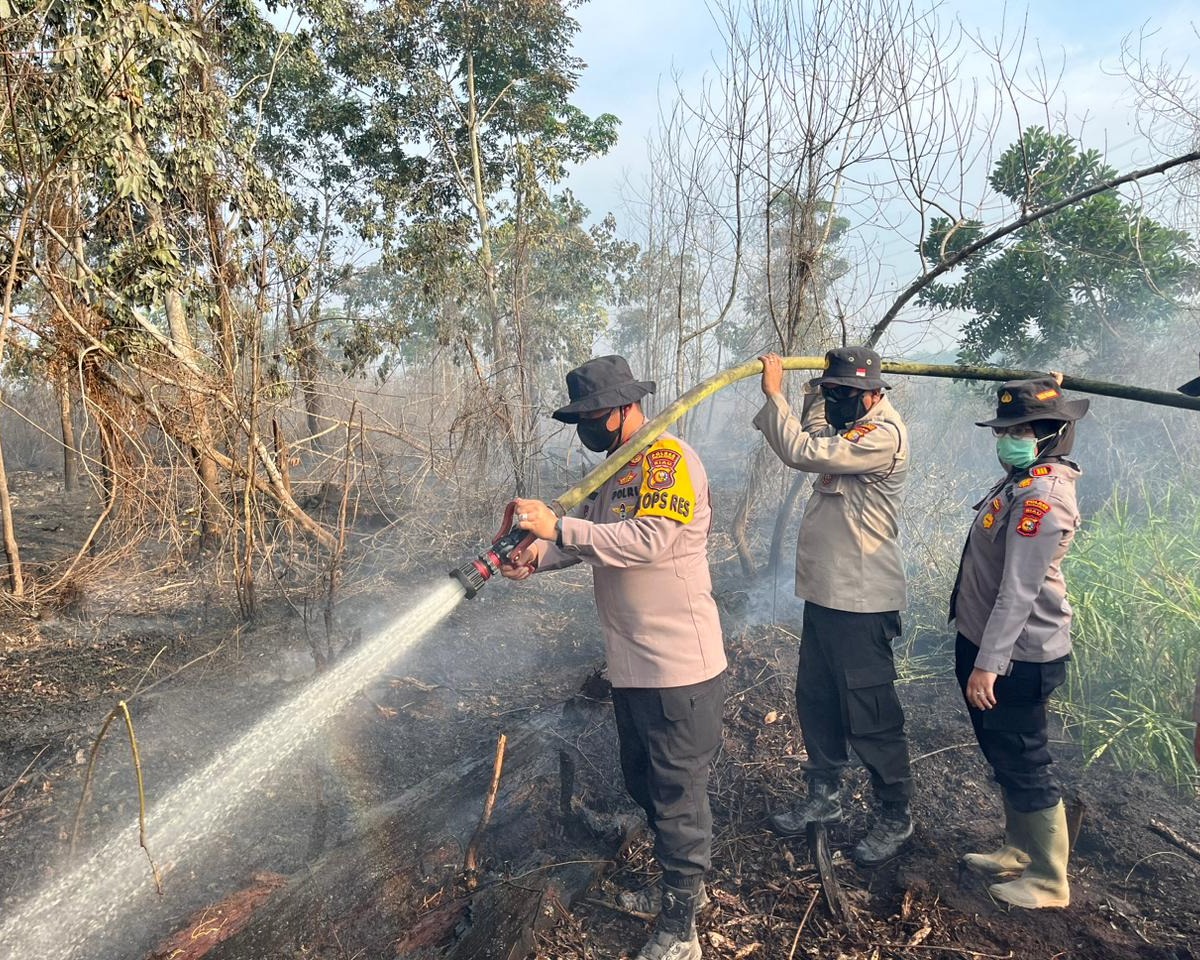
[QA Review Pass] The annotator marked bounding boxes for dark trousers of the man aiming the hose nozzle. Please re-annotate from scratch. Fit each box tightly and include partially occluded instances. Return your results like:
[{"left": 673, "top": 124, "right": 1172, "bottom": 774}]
[{"left": 612, "top": 673, "right": 725, "bottom": 887}]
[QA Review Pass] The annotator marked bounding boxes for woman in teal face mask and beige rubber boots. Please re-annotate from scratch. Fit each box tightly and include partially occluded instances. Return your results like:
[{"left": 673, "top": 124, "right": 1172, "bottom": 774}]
[{"left": 950, "top": 374, "right": 1088, "bottom": 908}]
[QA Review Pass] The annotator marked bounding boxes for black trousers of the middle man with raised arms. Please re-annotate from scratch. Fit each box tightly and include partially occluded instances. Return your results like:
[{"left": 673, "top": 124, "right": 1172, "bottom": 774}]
[{"left": 796, "top": 601, "right": 912, "bottom": 803}]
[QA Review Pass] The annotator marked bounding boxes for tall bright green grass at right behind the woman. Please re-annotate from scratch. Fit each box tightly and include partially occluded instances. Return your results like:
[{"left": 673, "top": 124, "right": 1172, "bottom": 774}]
[{"left": 1058, "top": 491, "right": 1200, "bottom": 786}]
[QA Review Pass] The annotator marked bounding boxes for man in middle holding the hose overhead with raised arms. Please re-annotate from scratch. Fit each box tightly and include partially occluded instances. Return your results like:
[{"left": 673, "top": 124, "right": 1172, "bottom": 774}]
[{"left": 754, "top": 347, "right": 912, "bottom": 866}]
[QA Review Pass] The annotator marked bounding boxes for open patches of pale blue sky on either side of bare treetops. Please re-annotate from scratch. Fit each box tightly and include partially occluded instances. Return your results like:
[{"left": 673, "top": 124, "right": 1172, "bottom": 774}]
[{"left": 570, "top": 0, "right": 1200, "bottom": 215}]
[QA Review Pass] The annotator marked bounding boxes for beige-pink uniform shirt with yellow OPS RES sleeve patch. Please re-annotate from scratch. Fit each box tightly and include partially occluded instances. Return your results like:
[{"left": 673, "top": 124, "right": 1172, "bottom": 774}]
[{"left": 538, "top": 433, "right": 726, "bottom": 688}]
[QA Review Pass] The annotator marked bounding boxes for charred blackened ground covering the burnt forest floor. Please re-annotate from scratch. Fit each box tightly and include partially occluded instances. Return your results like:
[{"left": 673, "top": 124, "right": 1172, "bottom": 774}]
[{"left": 0, "top": 468, "right": 1200, "bottom": 960}]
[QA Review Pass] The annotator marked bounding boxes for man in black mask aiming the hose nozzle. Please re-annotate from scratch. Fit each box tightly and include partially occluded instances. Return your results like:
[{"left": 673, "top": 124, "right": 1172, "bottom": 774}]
[{"left": 500, "top": 356, "right": 726, "bottom": 960}]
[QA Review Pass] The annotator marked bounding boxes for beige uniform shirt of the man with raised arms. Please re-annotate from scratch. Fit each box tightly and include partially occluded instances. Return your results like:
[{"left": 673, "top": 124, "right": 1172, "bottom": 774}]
[{"left": 754, "top": 394, "right": 908, "bottom": 613}]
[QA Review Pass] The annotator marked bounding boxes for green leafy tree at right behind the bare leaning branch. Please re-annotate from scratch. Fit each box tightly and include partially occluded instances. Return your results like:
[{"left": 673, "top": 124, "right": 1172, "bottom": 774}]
[{"left": 919, "top": 127, "right": 1198, "bottom": 367}]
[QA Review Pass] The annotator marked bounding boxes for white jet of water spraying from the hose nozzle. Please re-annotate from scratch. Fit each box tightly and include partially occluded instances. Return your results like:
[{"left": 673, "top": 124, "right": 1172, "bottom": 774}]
[{"left": 0, "top": 581, "right": 463, "bottom": 960}]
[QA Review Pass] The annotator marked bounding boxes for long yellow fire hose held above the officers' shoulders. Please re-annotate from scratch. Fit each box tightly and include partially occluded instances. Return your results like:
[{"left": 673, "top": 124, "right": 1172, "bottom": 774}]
[{"left": 552, "top": 356, "right": 1200, "bottom": 516}]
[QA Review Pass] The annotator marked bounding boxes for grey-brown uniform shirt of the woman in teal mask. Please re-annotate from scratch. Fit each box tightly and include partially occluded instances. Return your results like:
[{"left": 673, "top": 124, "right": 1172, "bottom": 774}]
[{"left": 950, "top": 462, "right": 1079, "bottom": 674}]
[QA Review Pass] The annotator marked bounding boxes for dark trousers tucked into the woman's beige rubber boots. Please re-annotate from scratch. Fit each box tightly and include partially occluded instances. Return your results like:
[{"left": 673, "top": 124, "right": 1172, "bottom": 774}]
[{"left": 954, "top": 634, "right": 1067, "bottom": 814}]
